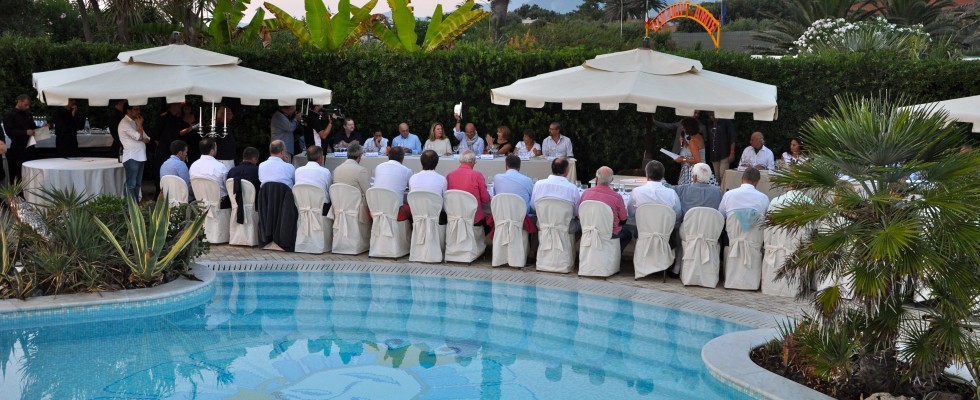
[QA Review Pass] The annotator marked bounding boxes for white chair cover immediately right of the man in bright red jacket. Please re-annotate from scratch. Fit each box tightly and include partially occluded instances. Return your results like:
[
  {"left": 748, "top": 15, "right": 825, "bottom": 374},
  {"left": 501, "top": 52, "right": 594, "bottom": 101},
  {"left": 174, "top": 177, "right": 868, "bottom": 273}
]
[{"left": 490, "top": 193, "right": 530, "bottom": 268}]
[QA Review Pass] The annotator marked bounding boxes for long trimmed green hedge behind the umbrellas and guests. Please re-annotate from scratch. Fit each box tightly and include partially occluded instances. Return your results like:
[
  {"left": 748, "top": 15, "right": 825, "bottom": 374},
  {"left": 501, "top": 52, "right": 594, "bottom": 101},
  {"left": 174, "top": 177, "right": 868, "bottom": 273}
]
[{"left": 0, "top": 36, "right": 980, "bottom": 182}]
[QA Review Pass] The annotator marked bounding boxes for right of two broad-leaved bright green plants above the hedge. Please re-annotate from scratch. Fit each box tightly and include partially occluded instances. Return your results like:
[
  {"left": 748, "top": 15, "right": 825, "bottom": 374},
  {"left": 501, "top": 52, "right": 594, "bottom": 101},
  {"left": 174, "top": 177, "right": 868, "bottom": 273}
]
[{"left": 373, "top": 0, "right": 490, "bottom": 53}]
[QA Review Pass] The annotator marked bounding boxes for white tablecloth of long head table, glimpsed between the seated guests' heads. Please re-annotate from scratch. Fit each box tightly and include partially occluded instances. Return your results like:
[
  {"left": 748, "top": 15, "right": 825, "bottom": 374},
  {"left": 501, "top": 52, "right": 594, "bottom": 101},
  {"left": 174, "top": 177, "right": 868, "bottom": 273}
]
[{"left": 293, "top": 154, "right": 578, "bottom": 183}]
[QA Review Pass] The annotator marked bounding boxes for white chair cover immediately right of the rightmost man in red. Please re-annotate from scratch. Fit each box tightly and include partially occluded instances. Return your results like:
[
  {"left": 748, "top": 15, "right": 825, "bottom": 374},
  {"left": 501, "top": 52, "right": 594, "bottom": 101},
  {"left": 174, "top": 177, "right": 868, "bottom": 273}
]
[{"left": 633, "top": 204, "right": 677, "bottom": 279}]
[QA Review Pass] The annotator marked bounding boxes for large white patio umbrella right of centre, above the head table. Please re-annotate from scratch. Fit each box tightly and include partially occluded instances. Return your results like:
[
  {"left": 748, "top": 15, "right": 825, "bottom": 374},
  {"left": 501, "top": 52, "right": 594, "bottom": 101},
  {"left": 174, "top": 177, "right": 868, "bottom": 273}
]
[{"left": 490, "top": 48, "right": 776, "bottom": 121}]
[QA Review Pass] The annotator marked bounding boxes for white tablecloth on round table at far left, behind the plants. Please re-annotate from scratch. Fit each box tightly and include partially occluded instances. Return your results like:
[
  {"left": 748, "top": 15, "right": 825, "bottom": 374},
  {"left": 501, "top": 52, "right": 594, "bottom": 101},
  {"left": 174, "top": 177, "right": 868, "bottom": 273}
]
[{"left": 21, "top": 157, "right": 126, "bottom": 203}]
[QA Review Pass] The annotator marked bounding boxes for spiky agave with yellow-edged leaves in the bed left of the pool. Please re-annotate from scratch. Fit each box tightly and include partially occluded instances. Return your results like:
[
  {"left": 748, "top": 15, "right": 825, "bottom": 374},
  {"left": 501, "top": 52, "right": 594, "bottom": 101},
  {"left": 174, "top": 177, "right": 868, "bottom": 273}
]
[{"left": 95, "top": 194, "right": 206, "bottom": 286}]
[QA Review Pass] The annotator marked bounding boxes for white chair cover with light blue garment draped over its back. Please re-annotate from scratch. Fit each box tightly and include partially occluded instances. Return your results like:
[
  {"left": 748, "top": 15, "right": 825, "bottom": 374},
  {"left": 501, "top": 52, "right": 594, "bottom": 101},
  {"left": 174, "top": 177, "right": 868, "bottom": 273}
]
[{"left": 725, "top": 209, "right": 764, "bottom": 290}]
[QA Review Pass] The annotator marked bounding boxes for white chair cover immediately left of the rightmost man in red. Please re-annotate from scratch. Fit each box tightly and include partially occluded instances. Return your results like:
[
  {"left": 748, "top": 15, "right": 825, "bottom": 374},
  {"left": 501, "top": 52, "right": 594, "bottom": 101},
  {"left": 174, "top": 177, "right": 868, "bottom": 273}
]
[{"left": 534, "top": 197, "right": 578, "bottom": 274}]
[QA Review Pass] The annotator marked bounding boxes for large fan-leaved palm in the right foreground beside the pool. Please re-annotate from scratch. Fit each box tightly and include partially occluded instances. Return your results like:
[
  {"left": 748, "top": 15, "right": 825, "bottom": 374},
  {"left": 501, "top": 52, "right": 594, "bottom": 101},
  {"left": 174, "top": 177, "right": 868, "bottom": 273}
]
[{"left": 769, "top": 97, "right": 980, "bottom": 396}]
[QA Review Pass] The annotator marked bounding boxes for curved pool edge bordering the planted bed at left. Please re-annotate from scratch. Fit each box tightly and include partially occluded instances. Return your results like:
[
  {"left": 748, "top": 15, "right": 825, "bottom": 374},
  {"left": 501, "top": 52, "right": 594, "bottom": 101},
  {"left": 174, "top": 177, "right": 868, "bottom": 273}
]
[{"left": 0, "top": 263, "right": 215, "bottom": 329}]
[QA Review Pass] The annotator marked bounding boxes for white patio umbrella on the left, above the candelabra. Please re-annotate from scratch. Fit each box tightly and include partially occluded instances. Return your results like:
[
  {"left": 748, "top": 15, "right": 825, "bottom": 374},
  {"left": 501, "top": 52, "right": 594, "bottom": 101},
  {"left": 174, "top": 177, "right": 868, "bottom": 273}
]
[{"left": 33, "top": 44, "right": 330, "bottom": 106}]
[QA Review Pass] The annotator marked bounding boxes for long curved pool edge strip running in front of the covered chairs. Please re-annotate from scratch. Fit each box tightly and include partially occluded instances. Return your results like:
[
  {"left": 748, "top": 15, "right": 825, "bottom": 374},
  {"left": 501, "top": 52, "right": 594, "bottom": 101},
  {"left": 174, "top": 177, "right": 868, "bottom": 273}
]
[{"left": 200, "top": 261, "right": 789, "bottom": 328}]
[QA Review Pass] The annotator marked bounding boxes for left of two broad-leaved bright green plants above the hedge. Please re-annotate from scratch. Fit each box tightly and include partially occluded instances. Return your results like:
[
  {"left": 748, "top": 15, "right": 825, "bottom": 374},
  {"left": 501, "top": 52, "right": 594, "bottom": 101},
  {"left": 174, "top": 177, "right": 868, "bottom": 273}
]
[{"left": 263, "top": 0, "right": 378, "bottom": 51}]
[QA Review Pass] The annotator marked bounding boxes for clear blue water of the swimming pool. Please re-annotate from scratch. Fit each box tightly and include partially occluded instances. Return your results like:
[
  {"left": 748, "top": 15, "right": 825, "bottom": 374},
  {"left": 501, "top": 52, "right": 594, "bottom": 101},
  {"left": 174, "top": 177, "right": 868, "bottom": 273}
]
[{"left": 0, "top": 272, "right": 747, "bottom": 400}]
